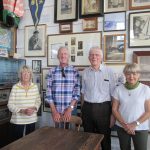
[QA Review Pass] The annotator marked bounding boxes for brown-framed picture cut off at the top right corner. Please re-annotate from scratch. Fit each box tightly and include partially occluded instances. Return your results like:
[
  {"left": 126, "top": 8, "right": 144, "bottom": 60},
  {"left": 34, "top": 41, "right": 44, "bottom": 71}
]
[{"left": 129, "top": 0, "right": 150, "bottom": 10}]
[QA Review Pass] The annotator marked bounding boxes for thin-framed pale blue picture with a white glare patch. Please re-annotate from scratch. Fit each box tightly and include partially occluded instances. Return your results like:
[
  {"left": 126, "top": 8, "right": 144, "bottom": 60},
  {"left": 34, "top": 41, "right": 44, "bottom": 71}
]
[{"left": 103, "top": 12, "right": 126, "bottom": 31}]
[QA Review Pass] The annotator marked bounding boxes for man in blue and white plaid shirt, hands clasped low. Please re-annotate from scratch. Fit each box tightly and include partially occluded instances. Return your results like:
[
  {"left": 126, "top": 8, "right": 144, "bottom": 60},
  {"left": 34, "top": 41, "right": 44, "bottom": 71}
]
[{"left": 46, "top": 47, "right": 80, "bottom": 126}]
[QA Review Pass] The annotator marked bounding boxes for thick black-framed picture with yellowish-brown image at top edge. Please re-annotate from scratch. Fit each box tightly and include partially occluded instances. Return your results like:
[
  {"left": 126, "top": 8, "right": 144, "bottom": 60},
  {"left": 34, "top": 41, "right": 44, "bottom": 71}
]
[{"left": 79, "top": 0, "right": 103, "bottom": 18}]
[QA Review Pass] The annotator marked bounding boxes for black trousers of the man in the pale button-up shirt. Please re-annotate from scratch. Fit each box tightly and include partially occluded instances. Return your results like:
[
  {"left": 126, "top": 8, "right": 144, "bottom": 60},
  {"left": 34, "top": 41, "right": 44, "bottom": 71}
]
[{"left": 82, "top": 102, "right": 111, "bottom": 150}]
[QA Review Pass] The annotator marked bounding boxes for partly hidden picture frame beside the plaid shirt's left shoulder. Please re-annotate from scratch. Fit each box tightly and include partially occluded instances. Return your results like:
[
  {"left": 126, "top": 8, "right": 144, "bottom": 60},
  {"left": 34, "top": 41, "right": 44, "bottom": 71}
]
[{"left": 42, "top": 68, "right": 50, "bottom": 90}]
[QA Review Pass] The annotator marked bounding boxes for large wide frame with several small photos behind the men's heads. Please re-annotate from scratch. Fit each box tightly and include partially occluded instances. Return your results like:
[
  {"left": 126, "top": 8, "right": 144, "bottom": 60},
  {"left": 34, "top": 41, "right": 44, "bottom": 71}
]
[{"left": 47, "top": 32, "right": 101, "bottom": 66}]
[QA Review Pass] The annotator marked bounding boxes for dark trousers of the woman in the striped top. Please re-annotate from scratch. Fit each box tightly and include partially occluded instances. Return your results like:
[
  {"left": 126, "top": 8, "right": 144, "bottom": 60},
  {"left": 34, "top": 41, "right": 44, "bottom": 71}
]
[{"left": 11, "top": 123, "right": 35, "bottom": 141}]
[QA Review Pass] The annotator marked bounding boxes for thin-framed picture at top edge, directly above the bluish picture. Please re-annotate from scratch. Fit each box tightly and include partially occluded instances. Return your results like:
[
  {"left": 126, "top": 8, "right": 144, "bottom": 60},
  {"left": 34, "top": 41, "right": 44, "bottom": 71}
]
[{"left": 104, "top": 0, "right": 127, "bottom": 13}]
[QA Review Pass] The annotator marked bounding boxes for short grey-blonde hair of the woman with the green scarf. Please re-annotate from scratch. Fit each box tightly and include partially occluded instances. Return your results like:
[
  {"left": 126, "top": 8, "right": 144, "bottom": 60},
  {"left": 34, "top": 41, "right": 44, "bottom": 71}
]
[{"left": 123, "top": 63, "right": 141, "bottom": 74}]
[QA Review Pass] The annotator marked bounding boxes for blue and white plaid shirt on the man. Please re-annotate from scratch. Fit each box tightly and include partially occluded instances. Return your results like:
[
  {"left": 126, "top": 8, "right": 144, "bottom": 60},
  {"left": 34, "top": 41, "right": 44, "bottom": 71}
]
[{"left": 46, "top": 66, "right": 80, "bottom": 113}]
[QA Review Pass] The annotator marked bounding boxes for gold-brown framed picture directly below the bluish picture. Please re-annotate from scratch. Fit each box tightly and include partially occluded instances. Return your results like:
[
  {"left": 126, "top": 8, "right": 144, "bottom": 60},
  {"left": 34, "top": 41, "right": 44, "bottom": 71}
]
[{"left": 104, "top": 34, "right": 126, "bottom": 63}]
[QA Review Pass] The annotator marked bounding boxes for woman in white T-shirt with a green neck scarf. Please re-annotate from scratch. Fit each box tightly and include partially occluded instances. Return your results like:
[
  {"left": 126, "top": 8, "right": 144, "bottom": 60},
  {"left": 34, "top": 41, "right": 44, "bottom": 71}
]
[{"left": 112, "top": 63, "right": 150, "bottom": 150}]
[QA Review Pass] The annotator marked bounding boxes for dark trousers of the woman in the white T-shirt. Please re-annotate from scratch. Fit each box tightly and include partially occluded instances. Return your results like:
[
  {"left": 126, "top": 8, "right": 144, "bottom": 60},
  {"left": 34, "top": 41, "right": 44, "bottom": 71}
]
[{"left": 117, "top": 127, "right": 148, "bottom": 150}]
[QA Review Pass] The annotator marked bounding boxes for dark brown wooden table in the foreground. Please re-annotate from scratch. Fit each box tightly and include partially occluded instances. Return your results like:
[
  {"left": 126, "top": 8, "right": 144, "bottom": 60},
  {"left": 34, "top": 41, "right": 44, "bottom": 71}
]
[{"left": 1, "top": 127, "right": 103, "bottom": 150}]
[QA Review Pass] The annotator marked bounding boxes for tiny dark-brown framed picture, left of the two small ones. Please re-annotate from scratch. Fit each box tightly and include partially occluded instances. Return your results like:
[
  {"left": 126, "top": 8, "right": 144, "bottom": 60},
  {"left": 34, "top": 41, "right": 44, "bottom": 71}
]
[{"left": 59, "top": 22, "right": 72, "bottom": 33}]
